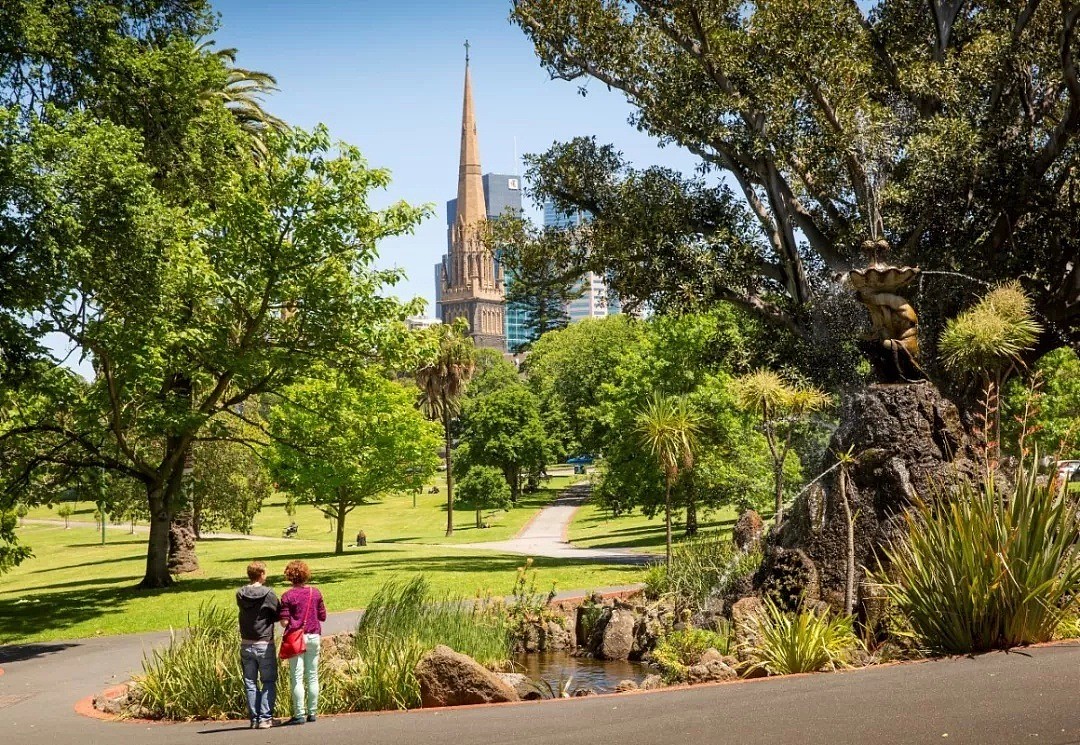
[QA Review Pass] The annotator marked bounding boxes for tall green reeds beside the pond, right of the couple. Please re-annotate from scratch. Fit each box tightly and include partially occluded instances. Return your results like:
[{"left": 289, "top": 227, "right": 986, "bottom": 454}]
[{"left": 355, "top": 575, "right": 511, "bottom": 710}]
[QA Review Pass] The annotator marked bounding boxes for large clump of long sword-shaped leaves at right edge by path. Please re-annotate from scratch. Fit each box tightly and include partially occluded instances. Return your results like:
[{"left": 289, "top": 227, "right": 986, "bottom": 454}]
[{"left": 879, "top": 469, "right": 1080, "bottom": 654}]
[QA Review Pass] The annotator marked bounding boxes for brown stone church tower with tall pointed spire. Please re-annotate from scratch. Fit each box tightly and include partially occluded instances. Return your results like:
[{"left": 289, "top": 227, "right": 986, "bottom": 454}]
[{"left": 441, "top": 49, "right": 507, "bottom": 351}]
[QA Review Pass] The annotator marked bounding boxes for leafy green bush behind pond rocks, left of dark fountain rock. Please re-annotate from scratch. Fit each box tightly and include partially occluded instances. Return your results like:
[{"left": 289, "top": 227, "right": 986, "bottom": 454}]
[{"left": 645, "top": 533, "right": 761, "bottom": 611}]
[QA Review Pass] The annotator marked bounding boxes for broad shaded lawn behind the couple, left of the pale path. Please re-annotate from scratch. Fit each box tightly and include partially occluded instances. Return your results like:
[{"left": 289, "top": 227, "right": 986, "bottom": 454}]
[{"left": 0, "top": 516, "right": 642, "bottom": 644}]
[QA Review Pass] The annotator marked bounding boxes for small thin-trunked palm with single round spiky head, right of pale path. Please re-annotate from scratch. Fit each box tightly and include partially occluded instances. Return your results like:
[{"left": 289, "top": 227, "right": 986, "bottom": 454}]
[{"left": 637, "top": 394, "right": 701, "bottom": 567}]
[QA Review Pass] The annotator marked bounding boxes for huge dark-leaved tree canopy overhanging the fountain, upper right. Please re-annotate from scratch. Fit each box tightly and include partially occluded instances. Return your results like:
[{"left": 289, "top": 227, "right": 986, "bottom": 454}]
[{"left": 511, "top": 0, "right": 1080, "bottom": 356}]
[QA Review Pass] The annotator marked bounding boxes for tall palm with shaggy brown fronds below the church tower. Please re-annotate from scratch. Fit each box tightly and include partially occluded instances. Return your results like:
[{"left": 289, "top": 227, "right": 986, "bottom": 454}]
[{"left": 416, "top": 319, "right": 476, "bottom": 536}]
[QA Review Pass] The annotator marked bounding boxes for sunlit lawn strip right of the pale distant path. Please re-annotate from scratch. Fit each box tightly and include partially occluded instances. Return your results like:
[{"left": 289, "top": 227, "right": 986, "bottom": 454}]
[{"left": 569, "top": 502, "right": 739, "bottom": 553}]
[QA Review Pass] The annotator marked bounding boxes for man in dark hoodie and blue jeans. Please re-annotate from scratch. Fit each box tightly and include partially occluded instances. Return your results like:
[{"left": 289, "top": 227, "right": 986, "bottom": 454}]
[{"left": 237, "top": 561, "right": 279, "bottom": 730}]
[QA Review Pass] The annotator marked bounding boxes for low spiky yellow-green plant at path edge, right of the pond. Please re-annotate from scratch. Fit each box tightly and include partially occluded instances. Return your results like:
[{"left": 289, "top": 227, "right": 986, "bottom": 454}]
[{"left": 745, "top": 600, "right": 859, "bottom": 675}]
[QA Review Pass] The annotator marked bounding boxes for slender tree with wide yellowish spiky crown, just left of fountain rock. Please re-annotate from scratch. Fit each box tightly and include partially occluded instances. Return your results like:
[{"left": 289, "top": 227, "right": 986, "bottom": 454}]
[{"left": 735, "top": 368, "right": 829, "bottom": 525}]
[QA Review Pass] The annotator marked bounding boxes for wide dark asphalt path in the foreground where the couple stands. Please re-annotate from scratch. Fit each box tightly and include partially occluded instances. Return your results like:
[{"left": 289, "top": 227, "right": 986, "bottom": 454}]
[{"left": 0, "top": 614, "right": 1080, "bottom": 745}]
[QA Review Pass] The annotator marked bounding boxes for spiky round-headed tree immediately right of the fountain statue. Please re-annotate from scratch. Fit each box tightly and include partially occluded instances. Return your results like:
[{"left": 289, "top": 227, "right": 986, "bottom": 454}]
[{"left": 939, "top": 282, "right": 1042, "bottom": 453}]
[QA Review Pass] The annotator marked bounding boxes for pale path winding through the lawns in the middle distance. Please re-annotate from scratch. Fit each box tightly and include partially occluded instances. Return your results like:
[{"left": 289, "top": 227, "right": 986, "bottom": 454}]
[{"left": 448, "top": 484, "right": 657, "bottom": 565}]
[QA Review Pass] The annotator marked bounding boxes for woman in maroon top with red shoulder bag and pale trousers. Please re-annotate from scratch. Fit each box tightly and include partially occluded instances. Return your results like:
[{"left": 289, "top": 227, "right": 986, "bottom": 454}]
[{"left": 280, "top": 560, "right": 326, "bottom": 724}]
